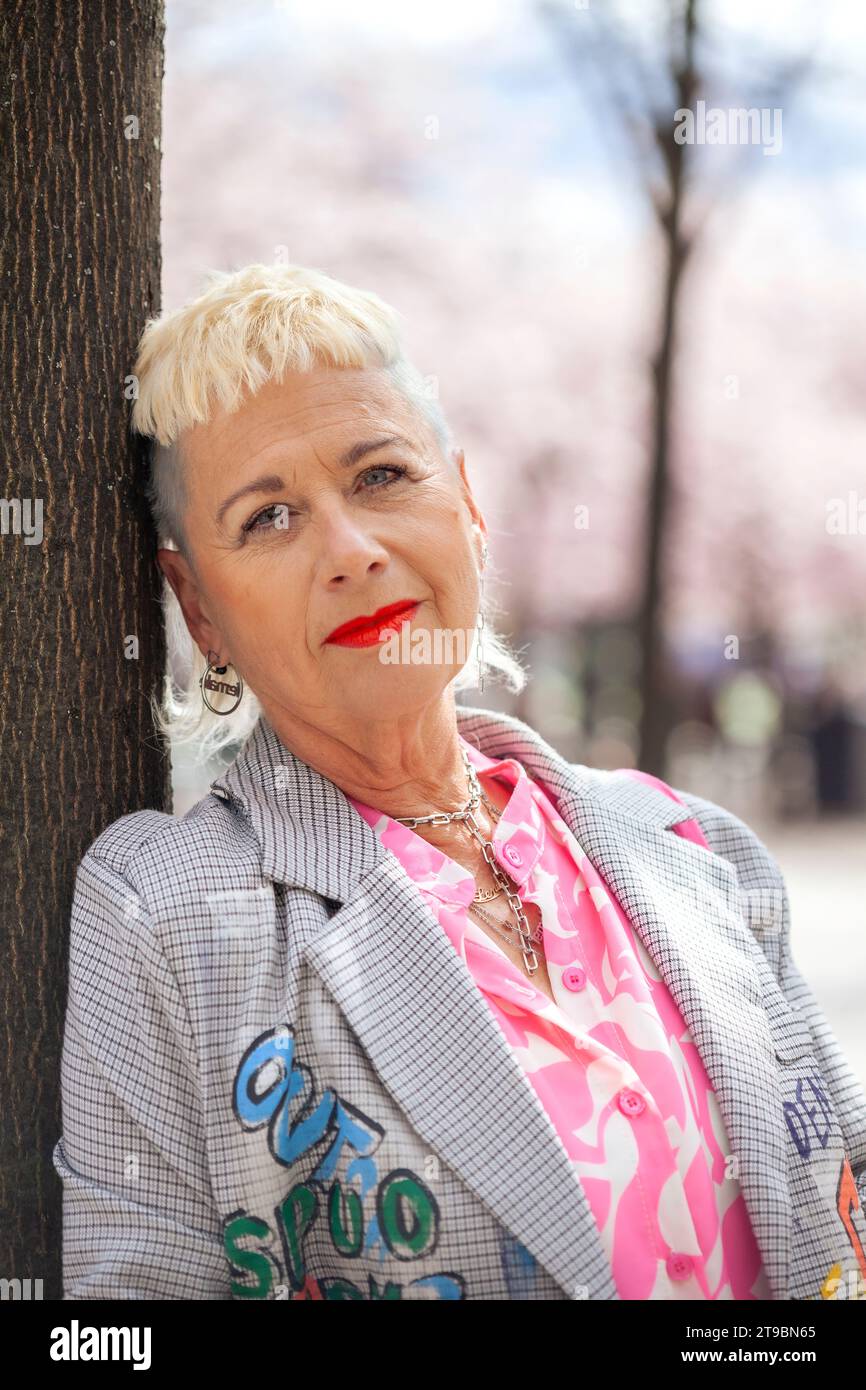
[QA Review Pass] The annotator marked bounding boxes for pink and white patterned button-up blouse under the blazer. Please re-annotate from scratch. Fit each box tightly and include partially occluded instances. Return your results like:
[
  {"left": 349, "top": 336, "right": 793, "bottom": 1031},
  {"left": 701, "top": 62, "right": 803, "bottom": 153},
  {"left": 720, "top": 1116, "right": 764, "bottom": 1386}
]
[{"left": 350, "top": 739, "right": 771, "bottom": 1300}]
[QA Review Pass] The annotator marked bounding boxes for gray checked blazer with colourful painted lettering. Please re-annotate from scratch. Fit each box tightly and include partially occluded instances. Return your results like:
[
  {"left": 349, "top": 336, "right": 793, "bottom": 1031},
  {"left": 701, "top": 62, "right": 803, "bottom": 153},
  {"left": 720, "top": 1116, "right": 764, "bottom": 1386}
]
[{"left": 54, "top": 706, "right": 866, "bottom": 1300}]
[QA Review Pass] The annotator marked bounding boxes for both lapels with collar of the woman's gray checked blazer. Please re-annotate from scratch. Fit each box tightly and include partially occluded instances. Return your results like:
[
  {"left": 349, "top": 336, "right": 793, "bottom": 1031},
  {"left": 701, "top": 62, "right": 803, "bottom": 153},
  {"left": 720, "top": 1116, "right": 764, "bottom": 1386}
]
[{"left": 213, "top": 706, "right": 790, "bottom": 1300}]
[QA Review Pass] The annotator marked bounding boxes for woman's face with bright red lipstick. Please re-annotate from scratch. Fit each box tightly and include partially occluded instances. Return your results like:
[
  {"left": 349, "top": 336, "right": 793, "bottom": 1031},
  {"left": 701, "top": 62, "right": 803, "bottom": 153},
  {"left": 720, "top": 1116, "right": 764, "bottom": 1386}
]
[{"left": 158, "top": 368, "right": 487, "bottom": 731}]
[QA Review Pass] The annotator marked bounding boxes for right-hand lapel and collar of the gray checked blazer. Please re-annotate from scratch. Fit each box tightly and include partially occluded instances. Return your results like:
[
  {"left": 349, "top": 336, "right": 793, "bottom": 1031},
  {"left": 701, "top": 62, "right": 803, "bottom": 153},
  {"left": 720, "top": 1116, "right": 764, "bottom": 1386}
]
[{"left": 460, "top": 710, "right": 791, "bottom": 1300}]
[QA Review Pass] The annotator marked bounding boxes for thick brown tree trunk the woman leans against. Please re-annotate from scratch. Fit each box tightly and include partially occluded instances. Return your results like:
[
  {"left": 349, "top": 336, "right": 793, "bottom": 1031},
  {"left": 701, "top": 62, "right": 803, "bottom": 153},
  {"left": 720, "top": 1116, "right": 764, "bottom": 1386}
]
[{"left": 0, "top": 0, "right": 171, "bottom": 1298}]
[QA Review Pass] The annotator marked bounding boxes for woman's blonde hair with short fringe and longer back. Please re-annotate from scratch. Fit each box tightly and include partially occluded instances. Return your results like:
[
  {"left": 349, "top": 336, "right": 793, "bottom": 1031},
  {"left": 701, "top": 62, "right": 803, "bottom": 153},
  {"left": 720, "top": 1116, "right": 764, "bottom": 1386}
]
[{"left": 131, "top": 264, "right": 527, "bottom": 760}]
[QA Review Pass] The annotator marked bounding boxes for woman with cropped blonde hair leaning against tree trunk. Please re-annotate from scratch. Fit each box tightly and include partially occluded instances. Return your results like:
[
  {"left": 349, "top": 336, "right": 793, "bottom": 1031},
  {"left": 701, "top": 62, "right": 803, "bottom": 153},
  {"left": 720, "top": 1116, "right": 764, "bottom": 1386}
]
[{"left": 54, "top": 265, "right": 866, "bottom": 1300}]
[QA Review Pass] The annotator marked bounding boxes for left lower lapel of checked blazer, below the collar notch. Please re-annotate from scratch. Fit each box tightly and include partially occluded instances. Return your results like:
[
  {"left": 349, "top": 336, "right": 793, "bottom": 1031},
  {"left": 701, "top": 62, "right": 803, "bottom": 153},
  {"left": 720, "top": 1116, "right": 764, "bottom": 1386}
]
[{"left": 306, "top": 858, "right": 616, "bottom": 1298}]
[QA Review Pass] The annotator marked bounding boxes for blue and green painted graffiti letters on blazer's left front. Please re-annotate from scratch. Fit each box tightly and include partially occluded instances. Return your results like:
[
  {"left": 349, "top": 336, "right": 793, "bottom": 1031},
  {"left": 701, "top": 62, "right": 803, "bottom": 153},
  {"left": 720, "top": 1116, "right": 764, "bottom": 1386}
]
[{"left": 224, "top": 1027, "right": 464, "bottom": 1300}]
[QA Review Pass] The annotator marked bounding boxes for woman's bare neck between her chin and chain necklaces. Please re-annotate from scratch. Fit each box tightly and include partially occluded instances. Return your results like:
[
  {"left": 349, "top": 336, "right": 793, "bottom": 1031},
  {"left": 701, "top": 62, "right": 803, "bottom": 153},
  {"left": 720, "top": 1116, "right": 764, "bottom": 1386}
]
[{"left": 264, "top": 689, "right": 470, "bottom": 830}]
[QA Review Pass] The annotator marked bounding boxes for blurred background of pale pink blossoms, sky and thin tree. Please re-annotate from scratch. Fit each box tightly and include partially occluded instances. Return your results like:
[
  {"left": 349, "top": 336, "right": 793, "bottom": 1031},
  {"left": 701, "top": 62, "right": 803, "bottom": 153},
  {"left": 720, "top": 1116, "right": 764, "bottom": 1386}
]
[{"left": 163, "top": 0, "right": 866, "bottom": 1079}]
